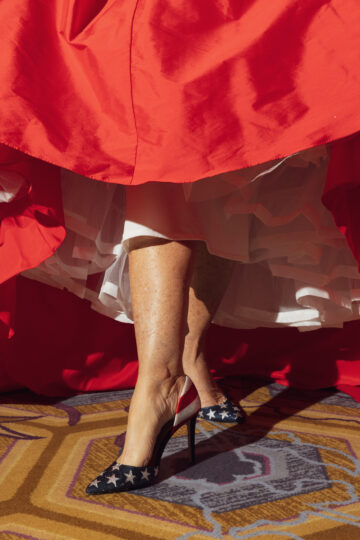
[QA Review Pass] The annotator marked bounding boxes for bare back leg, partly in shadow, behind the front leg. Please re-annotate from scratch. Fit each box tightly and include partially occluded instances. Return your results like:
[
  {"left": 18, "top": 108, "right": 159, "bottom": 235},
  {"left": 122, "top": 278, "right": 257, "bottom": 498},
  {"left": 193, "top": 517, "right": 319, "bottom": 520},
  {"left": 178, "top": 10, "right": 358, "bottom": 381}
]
[{"left": 183, "top": 242, "right": 235, "bottom": 407}]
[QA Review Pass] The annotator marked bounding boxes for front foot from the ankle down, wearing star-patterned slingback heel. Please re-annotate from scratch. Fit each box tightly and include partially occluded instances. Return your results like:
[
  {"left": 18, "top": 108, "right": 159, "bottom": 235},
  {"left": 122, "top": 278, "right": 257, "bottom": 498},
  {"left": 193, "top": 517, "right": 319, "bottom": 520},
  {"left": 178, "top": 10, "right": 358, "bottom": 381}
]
[{"left": 86, "top": 376, "right": 200, "bottom": 495}]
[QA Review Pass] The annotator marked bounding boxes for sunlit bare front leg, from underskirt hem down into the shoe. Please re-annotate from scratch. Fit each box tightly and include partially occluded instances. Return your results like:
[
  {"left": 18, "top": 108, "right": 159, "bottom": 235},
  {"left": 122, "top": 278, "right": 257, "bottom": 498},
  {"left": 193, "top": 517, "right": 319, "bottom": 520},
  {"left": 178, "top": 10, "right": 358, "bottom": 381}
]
[{"left": 118, "top": 238, "right": 192, "bottom": 466}]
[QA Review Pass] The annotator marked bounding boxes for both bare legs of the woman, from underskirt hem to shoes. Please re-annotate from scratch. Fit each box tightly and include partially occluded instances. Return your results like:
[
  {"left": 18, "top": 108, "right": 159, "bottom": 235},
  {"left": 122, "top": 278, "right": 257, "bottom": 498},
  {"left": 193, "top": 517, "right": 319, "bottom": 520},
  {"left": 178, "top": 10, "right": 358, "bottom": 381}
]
[{"left": 118, "top": 237, "right": 234, "bottom": 466}]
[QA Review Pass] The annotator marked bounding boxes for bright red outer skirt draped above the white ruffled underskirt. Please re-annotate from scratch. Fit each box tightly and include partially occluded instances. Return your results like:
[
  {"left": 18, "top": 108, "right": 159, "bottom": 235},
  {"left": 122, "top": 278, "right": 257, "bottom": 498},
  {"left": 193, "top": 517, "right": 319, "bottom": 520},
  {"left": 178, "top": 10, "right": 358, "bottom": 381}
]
[{"left": 0, "top": 0, "right": 360, "bottom": 338}]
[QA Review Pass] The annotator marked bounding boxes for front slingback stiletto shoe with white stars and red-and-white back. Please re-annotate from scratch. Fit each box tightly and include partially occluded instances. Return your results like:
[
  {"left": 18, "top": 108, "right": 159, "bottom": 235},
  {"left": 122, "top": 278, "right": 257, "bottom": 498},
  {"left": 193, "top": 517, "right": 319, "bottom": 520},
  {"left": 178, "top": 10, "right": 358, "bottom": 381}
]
[{"left": 86, "top": 377, "right": 200, "bottom": 495}]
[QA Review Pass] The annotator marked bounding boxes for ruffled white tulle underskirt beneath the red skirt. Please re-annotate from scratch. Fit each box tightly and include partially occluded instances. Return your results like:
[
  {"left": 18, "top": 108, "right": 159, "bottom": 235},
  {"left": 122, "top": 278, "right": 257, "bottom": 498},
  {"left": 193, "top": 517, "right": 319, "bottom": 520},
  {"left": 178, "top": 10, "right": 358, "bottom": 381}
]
[{"left": 24, "top": 147, "right": 360, "bottom": 330}]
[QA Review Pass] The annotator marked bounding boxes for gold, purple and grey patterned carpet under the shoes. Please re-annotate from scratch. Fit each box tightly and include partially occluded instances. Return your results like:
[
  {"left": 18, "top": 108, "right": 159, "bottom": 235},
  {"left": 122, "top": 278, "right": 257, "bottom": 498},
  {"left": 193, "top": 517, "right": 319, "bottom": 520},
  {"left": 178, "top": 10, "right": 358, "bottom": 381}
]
[{"left": 0, "top": 380, "right": 360, "bottom": 540}]
